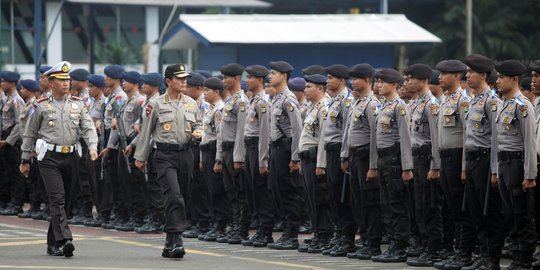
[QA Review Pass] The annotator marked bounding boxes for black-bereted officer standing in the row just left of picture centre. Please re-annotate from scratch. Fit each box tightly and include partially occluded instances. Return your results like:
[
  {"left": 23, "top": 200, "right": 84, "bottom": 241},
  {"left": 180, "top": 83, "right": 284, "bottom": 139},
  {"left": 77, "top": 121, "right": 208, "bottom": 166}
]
[{"left": 242, "top": 65, "right": 275, "bottom": 247}]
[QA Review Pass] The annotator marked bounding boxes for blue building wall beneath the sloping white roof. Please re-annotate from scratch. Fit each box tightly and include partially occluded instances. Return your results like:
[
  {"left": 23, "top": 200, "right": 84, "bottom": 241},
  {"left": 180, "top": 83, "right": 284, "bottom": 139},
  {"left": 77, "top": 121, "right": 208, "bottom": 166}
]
[{"left": 196, "top": 44, "right": 394, "bottom": 76}]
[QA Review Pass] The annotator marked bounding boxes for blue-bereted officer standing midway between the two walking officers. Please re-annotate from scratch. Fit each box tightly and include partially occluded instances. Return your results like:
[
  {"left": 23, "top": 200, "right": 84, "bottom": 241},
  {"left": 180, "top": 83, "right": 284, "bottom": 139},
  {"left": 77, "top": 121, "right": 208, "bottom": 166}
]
[{"left": 96, "top": 65, "right": 128, "bottom": 229}]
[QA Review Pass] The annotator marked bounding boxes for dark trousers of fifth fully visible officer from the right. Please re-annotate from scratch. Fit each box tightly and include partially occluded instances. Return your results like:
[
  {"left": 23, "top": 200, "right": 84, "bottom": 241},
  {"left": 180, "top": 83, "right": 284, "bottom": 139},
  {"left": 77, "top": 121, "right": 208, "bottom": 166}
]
[{"left": 377, "top": 143, "right": 411, "bottom": 248}]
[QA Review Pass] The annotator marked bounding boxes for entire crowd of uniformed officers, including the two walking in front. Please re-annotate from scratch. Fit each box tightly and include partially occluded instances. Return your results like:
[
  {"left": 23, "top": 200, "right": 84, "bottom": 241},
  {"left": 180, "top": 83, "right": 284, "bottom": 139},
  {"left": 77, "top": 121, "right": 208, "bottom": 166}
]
[{"left": 0, "top": 54, "right": 540, "bottom": 270}]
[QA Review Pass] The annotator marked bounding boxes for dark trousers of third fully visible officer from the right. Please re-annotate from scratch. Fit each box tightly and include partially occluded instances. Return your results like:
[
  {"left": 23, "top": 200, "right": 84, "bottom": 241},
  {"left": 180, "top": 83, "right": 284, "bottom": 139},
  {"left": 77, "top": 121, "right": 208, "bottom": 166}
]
[{"left": 440, "top": 148, "right": 476, "bottom": 254}]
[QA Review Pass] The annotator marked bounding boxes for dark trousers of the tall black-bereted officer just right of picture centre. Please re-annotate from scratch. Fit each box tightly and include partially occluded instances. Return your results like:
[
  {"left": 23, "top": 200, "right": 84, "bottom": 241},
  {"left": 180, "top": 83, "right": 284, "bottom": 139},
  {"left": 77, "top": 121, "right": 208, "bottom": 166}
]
[{"left": 268, "top": 138, "right": 302, "bottom": 231}]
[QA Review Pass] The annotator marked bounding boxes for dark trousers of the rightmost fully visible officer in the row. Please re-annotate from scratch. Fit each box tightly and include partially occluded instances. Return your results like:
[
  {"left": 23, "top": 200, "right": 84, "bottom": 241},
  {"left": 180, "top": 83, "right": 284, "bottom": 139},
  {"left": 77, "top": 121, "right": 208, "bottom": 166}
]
[{"left": 498, "top": 151, "right": 536, "bottom": 262}]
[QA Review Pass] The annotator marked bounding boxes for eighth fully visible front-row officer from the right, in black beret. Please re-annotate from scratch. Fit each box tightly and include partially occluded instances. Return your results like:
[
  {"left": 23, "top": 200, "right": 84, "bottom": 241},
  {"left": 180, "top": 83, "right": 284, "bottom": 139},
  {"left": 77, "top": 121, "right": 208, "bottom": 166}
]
[{"left": 298, "top": 74, "right": 334, "bottom": 253}]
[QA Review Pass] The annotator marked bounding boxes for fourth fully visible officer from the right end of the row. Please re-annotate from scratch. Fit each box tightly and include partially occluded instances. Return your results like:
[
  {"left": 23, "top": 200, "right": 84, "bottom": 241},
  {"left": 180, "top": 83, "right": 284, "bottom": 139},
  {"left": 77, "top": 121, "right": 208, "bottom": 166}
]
[{"left": 407, "top": 64, "right": 442, "bottom": 266}]
